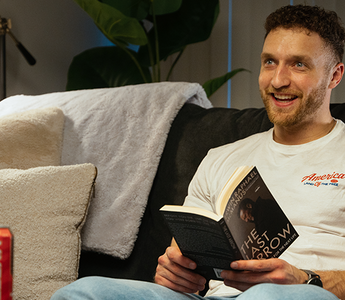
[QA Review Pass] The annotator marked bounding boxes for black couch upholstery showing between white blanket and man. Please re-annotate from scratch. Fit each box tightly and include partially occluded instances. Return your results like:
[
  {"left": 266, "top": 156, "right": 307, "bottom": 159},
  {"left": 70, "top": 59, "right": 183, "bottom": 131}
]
[{"left": 79, "top": 104, "right": 345, "bottom": 281}]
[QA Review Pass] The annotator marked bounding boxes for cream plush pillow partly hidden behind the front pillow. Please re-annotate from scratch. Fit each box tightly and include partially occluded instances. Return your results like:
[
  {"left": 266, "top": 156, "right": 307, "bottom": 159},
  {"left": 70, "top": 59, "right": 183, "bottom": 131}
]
[{"left": 0, "top": 107, "right": 64, "bottom": 169}]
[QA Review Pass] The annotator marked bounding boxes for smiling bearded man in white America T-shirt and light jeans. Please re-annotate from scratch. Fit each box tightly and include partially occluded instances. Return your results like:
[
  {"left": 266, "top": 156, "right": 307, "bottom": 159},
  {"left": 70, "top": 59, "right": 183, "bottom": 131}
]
[{"left": 53, "top": 6, "right": 345, "bottom": 300}]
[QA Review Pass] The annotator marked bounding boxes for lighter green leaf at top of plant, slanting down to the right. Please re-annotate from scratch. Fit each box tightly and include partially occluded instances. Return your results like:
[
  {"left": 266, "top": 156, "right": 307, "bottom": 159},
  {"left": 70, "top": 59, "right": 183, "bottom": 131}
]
[{"left": 74, "top": 0, "right": 147, "bottom": 45}]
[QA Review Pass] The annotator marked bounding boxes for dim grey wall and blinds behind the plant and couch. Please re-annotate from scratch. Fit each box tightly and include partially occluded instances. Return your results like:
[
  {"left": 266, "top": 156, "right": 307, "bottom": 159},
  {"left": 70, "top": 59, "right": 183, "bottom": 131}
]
[{"left": 0, "top": 0, "right": 345, "bottom": 108}]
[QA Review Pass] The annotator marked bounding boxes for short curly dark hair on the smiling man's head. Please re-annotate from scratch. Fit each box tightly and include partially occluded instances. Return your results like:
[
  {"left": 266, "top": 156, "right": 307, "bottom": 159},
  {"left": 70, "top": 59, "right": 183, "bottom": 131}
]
[{"left": 265, "top": 4, "right": 345, "bottom": 63}]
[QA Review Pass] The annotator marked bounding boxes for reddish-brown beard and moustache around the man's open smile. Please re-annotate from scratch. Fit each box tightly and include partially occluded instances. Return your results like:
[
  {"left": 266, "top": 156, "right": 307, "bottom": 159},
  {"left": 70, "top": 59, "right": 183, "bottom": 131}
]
[{"left": 260, "top": 82, "right": 327, "bottom": 127}]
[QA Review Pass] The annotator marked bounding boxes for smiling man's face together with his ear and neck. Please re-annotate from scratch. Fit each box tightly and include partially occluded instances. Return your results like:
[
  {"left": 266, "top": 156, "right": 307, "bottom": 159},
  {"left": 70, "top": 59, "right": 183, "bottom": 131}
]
[{"left": 259, "top": 22, "right": 344, "bottom": 144}]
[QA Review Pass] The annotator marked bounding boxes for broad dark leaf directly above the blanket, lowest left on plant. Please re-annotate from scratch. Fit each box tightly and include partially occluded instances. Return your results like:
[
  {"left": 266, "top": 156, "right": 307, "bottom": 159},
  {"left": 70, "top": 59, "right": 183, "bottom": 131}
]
[{"left": 66, "top": 47, "right": 151, "bottom": 90}]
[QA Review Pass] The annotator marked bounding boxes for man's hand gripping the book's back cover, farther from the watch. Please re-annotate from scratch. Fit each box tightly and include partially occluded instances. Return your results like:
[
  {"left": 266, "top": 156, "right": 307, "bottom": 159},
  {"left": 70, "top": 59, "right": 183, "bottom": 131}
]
[{"left": 155, "top": 246, "right": 206, "bottom": 293}]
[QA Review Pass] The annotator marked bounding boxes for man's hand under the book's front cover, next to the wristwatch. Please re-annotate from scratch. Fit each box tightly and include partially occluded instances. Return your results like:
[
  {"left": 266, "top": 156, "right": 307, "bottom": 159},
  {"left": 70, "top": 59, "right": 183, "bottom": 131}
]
[{"left": 221, "top": 258, "right": 308, "bottom": 291}]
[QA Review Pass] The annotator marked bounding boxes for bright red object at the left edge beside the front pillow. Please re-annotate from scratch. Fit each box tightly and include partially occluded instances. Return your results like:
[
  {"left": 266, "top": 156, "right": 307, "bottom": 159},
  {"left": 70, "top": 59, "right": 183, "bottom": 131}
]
[{"left": 0, "top": 227, "right": 13, "bottom": 300}]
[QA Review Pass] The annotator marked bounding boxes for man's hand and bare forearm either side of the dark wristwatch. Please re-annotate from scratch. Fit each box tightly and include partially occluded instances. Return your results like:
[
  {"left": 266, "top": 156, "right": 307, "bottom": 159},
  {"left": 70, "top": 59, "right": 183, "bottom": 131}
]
[{"left": 222, "top": 258, "right": 345, "bottom": 299}]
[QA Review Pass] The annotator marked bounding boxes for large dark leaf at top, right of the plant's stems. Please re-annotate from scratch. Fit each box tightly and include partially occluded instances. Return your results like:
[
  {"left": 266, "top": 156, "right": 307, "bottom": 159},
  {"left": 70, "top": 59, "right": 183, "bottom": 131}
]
[{"left": 139, "top": 0, "right": 219, "bottom": 65}]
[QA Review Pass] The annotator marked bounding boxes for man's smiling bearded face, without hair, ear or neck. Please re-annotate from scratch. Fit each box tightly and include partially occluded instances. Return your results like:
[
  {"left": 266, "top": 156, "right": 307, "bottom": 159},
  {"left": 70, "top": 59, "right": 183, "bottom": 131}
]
[{"left": 259, "top": 28, "right": 332, "bottom": 127}]
